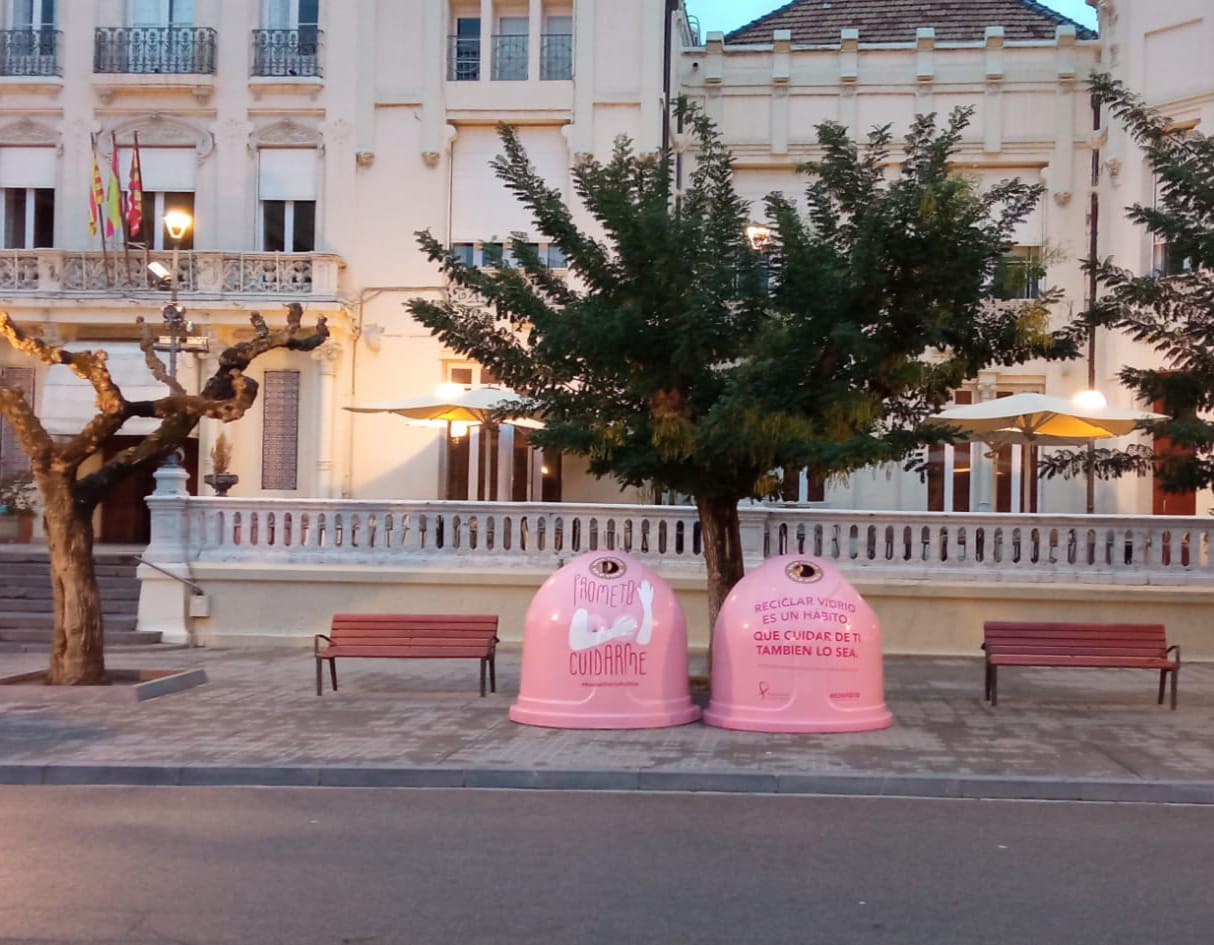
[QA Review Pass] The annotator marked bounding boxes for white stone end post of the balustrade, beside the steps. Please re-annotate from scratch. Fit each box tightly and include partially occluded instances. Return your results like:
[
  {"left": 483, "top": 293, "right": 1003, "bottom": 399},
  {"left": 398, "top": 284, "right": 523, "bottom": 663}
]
[{"left": 136, "top": 464, "right": 192, "bottom": 644}]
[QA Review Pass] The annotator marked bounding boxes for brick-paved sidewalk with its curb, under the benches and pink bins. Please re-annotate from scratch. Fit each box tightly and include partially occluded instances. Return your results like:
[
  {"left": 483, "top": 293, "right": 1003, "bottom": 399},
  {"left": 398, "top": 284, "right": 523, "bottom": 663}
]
[{"left": 0, "top": 649, "right": 1214, "bottom": 803}]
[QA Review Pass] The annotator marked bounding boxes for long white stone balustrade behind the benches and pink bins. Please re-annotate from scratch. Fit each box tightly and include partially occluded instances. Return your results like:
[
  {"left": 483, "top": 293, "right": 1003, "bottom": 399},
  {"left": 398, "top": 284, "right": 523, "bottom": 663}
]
[{"left": 173, "top": 498, "right": 1214, "bottom": 584}]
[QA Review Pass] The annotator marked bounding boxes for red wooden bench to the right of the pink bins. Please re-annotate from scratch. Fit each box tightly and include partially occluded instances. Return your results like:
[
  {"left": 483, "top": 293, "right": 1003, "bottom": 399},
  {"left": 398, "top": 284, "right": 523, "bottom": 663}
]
[{"left": 982, "top": 621, "right": 1180, "bottom": 708}]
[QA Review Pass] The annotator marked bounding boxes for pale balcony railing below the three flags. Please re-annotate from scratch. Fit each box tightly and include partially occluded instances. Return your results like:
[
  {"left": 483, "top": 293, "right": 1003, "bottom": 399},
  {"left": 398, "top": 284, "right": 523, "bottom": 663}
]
[{"left": 0, "top": 249, "right": 342, "bottom": 301}]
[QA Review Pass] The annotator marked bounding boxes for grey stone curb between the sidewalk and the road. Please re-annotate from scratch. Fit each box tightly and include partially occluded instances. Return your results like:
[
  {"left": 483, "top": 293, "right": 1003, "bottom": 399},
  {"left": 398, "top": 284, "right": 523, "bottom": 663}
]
[{"left": 0, "top": 764, "right": 1214, "bottom": 804}]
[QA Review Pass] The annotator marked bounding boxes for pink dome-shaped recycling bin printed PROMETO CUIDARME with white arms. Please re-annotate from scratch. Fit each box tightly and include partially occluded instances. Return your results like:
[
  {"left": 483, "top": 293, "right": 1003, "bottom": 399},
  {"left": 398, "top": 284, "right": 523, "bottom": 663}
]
[{"left": 510, "top": 551, "right": 699, "bottom": 729}]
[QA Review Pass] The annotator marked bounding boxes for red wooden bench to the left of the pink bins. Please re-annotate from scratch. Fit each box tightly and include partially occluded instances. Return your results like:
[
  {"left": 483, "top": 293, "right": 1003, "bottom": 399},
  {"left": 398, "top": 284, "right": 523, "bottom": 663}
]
[{"left": 312, "top": 613, "right": 498, "bottom": 697}]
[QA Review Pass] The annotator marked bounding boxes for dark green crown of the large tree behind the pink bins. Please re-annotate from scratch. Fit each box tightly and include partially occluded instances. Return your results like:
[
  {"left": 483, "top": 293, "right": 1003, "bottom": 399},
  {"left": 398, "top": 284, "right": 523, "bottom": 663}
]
[{"left": 409, "top": 104, "right": 1074, "bottom": 498}]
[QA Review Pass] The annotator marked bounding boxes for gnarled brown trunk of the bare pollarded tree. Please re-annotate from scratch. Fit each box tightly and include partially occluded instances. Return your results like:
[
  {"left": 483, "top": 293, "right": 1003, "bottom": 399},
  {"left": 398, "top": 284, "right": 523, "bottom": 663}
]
[{"left": 41, "top": 470, "right": 108, "bottom": 686}]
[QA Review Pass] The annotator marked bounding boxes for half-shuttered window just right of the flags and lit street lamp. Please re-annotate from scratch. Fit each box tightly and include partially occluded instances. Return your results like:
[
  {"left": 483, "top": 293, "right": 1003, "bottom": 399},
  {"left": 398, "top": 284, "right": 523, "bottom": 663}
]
[{"left": 257, "top": 148, "right": 318, "bottom": 253}]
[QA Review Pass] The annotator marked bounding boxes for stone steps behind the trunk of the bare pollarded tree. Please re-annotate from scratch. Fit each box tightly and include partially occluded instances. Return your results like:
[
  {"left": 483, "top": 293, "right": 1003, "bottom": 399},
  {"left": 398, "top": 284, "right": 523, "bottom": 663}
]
[{"left": 0, "top": 544, "right": 160, "bottom": 650}]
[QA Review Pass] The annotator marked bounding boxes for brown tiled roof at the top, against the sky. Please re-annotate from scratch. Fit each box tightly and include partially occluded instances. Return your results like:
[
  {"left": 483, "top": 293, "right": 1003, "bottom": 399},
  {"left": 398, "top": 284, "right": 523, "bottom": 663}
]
[{"left": 725, "top": 0, "right": 1096, "bottom": 46}]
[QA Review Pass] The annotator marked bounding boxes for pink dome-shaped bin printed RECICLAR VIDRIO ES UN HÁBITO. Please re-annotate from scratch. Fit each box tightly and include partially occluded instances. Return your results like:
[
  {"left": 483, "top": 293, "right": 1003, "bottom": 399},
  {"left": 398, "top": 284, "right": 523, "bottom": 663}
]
[{"left": 704, "top": 555, "right": 894, "bottom": 731}]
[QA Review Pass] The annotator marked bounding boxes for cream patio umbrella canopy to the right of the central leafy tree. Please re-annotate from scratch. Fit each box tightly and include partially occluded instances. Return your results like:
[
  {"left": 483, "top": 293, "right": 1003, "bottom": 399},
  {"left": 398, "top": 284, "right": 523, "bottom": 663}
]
[{"left": 927, "top": 394, "right": 1164, "bottom": 446}]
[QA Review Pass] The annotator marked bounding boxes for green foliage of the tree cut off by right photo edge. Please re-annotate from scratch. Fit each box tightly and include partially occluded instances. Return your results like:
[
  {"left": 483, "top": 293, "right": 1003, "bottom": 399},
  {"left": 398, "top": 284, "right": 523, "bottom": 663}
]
[{"left": 1085, "top": 75, "right": 1214, "bottom": 492}]
